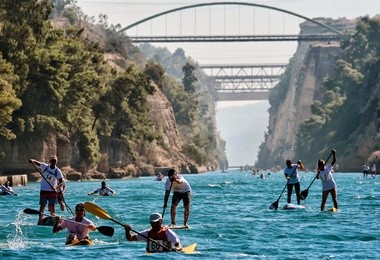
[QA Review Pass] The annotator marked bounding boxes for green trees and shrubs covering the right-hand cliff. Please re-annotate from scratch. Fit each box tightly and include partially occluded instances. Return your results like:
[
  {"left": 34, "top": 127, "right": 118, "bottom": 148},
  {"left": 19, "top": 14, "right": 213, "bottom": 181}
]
[{"left": 296, "top": 17, "right": 380, "bottom": 165}]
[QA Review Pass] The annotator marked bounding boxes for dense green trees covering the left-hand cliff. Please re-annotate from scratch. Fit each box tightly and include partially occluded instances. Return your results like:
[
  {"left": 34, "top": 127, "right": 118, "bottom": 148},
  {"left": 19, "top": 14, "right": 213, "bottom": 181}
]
[{"left": 0, "top": 0, "right": 224, "bottom": 171}]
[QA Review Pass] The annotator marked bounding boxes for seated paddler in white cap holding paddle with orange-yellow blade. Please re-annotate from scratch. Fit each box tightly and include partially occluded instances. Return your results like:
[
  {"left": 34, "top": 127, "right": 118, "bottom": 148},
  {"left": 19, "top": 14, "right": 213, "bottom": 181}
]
[{"left": 124, "top": 212, "right": 182, "bottom": 253}]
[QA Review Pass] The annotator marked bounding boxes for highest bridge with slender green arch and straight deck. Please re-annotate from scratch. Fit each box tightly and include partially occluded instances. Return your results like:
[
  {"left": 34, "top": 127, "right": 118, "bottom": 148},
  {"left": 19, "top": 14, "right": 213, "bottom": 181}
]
[{"left": 119, "top": 2, "right": 342, "bottom": 43}]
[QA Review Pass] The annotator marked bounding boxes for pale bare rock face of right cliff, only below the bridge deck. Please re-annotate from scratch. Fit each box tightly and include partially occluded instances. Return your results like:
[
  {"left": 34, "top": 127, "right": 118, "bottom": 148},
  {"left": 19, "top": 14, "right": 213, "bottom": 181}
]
[{"left": 266, "top": 43, "right": 340, "bottom": 161}]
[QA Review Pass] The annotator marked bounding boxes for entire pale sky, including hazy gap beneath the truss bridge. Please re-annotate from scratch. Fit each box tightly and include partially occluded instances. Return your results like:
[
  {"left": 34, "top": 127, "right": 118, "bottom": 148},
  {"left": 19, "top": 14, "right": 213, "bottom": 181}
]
[{"left": 77, "top": 0, "right": 380, "bottom": 166}]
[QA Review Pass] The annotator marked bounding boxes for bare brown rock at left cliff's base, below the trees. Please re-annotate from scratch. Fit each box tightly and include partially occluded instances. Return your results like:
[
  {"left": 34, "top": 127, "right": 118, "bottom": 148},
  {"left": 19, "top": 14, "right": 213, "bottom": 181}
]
[{"left": 0, "top": 82, "right": 205, "bottom": 181}]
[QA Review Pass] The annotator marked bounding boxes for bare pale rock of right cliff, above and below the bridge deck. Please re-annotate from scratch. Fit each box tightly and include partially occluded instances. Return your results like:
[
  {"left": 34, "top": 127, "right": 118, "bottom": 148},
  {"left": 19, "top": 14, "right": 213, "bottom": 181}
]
[{"left": 257, "top": 18, "right": 356, "bottom": 167}]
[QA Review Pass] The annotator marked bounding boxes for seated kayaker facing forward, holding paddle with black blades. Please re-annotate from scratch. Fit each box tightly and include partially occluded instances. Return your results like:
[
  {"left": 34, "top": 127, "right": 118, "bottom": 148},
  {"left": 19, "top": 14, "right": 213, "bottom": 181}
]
[{"left": 53, "top": 203, "right": 96, "bottom": 245}]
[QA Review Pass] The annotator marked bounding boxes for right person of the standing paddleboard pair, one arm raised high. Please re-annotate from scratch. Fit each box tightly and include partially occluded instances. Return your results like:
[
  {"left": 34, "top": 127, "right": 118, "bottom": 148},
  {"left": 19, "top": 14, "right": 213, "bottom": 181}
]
[{"left": 317, "top": 150, "right": 338, "bottom": 211}]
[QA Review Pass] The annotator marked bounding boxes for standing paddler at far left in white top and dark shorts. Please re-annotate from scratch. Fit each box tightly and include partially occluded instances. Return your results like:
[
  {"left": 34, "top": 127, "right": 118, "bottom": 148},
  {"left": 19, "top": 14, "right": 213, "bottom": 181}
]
[{"left": 29, "top": 155, "right": 63, "bottom": 221}]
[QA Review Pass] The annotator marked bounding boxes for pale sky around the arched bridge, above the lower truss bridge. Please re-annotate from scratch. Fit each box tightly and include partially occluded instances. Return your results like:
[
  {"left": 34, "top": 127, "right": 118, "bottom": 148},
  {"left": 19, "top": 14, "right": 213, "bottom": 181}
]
[{"left": 77, "top": 0, "right": 380, "bottom": 64}]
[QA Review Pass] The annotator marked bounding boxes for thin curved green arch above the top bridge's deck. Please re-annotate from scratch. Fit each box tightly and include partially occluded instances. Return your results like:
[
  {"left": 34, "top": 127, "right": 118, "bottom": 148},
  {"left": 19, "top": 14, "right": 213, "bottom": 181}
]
[{"left": 118, "top": 2, "right": 343, "bottom": 35}]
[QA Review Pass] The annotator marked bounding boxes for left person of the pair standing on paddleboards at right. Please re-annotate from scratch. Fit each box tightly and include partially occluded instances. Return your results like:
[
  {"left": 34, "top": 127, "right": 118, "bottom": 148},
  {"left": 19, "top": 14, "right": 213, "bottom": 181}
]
[{"left": 284, "top": 159, "right": 304, "bottom": 205}]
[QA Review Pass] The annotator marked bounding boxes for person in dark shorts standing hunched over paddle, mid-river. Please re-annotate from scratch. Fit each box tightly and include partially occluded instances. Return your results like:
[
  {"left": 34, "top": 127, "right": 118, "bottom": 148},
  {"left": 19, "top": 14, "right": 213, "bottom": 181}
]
[{"left": 163, "top": 169, "right": 191, "bottom": 227}]
